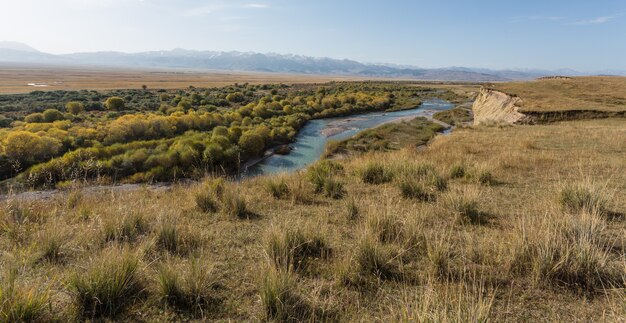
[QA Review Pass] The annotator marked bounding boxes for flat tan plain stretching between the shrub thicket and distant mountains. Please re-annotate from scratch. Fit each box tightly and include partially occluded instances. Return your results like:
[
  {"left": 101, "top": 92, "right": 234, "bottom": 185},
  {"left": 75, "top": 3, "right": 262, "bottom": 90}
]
[{"left": 0, "top": 64, "right": 479, "bottom": 94}]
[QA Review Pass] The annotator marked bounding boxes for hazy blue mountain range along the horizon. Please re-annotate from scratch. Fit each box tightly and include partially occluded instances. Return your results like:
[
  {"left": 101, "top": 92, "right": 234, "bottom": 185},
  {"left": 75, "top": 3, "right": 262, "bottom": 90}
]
[{"left": 0, "top": 41, "right": 626, "bottom": 82}]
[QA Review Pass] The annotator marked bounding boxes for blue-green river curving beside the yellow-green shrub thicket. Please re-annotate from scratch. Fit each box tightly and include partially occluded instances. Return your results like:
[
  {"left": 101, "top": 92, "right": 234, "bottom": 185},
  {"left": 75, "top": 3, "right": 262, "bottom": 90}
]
[{"left": 242, "top": 99, "right": 454, "bottom": 177}]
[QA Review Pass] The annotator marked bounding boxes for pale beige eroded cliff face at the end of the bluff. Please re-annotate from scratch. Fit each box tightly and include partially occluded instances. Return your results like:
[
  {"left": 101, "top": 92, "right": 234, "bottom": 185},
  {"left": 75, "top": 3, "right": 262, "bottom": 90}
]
[{"left": 472, "top": 88, "right": 526, "bottom": 125}]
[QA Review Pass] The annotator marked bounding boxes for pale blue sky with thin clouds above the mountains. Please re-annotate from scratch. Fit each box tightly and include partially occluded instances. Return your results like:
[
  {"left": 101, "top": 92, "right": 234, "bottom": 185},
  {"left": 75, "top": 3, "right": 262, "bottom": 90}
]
[{"left": 0, "top": 0, "right": 626, "bottom": 71}]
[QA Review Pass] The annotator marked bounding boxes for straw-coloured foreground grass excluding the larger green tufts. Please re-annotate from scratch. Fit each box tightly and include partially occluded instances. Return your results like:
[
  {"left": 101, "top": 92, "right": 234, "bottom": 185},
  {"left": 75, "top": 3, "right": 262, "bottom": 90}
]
[{"left": 0, "top": 119, "right": 626, "bottom": 321}]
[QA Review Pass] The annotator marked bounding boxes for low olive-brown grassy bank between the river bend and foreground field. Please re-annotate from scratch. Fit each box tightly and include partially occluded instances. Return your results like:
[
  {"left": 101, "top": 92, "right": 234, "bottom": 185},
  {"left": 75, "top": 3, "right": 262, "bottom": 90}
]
[{"left": 325, "top": 117, "right": 444, "bottom": 157}]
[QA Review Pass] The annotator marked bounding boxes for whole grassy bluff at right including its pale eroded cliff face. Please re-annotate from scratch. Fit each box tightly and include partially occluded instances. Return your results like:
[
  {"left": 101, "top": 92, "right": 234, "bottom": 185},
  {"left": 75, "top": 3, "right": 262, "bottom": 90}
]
[{"left": 472, "top": 76, "right": 626, "bottom": 124}]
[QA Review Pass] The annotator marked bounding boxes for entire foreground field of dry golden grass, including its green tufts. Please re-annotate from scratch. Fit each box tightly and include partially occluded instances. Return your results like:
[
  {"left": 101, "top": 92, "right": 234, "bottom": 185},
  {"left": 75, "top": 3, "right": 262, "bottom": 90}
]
[{"left": 0, "top": 119, "right": 626, "bottom": 322}]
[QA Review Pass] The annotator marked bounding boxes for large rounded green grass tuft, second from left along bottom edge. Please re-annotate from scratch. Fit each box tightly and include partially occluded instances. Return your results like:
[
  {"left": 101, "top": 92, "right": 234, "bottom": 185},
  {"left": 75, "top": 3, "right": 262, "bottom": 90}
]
[{"left": 68, "top": 251, "right": 143, "bottom": 318}]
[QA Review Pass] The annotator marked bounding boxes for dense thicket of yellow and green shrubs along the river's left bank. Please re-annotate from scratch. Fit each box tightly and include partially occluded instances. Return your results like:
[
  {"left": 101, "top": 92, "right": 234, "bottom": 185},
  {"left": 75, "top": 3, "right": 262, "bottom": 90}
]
[{"left": 0, "top": 82, "right": 463, "bottom": 188}]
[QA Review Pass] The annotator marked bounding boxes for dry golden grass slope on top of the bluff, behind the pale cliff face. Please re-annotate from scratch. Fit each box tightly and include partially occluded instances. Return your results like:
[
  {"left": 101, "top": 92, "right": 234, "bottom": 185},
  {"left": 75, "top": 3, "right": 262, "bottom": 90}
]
[{"left": 492, "top": 77, "right": 626, "bottom": 112}]
